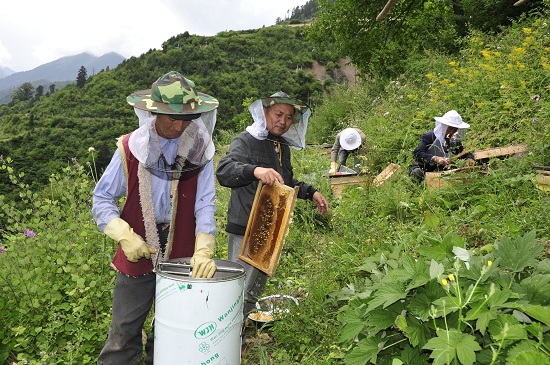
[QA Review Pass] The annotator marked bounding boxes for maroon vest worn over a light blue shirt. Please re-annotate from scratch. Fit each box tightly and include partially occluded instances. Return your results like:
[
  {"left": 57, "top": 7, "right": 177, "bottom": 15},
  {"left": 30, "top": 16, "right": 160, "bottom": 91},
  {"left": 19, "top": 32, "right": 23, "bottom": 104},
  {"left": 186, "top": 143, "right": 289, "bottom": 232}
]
[{"left": 113, "top": 133, "right": 200, "bottom": 276}]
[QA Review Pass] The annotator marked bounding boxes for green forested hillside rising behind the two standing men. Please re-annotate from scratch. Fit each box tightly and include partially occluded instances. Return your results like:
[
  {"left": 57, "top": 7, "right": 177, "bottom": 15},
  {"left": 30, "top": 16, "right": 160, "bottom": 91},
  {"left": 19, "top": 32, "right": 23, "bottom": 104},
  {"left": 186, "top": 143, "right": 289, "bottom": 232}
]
[{"left": 0, "top": 26, "right": 344, "bottom": 200}]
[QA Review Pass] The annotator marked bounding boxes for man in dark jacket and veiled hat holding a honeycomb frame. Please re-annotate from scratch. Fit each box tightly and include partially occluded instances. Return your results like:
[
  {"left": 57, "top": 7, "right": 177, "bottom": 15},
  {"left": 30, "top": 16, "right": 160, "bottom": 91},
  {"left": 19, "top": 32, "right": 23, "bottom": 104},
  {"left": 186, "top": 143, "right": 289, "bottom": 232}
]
[{"left": 216, "top": 91, "right": 329, "bottom": 344}]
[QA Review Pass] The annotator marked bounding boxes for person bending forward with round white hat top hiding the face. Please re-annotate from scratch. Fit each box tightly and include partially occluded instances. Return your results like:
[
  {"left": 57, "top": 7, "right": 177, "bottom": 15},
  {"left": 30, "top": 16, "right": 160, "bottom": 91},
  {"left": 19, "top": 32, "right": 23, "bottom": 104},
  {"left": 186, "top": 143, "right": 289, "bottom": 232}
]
[{"left": 329, "top": 128, "right": 369, "bottom": 175}]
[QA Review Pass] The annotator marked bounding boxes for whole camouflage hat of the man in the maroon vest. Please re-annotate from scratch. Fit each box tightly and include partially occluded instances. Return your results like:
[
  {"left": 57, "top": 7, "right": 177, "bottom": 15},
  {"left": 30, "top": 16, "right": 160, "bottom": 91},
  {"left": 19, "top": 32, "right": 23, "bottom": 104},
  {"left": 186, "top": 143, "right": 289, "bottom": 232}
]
[{"left": 126, "top": 71, "right": 219, "bottom": 114}]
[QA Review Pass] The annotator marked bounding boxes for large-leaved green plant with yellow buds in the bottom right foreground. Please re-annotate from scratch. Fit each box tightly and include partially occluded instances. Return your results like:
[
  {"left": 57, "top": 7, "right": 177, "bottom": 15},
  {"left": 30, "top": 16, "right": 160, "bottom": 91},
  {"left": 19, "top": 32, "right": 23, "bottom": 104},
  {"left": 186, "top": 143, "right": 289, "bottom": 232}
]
[{"left": 333, "top": 232, "right": 550, "bottom": 365}]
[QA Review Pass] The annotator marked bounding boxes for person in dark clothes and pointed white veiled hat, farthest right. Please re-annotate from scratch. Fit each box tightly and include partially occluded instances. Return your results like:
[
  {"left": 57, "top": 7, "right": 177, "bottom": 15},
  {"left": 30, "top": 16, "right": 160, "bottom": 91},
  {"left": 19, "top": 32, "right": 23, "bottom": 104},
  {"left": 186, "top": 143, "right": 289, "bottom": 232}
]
[{"left": 409, "top": 110, "right": 475, "bottom": 182}]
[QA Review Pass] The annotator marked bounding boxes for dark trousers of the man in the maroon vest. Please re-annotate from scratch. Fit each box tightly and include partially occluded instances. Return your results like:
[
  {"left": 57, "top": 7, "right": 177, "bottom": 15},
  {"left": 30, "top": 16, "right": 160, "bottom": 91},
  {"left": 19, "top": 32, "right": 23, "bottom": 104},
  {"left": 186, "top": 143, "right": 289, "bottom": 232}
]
[{"left": 97, "top": 225, "right": 169, "bottom": 365}]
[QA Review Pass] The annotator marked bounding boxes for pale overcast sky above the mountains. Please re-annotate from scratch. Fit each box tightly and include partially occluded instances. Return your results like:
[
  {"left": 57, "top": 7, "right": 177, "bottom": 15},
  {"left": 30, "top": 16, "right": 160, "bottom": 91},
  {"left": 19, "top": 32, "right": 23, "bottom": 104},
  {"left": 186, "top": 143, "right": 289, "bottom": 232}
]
[{"left": 0, "top": 0, "right": 307, "bottom": 72}]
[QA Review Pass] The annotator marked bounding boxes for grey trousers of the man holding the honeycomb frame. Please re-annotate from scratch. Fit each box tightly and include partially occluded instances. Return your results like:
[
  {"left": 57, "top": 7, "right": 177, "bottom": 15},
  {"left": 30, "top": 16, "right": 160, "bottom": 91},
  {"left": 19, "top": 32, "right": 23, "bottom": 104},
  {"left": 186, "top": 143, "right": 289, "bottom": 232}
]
[{"left": 227, "top": 233, "right": 267, "bottom": 319}]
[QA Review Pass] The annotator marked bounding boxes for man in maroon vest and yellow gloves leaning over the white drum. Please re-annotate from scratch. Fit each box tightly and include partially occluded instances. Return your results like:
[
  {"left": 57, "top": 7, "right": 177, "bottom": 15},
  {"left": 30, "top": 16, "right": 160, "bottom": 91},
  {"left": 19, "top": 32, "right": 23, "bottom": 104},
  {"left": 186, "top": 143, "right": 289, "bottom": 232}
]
[{"left": 92, "top": 71, "right": 219, "bottom": 365}]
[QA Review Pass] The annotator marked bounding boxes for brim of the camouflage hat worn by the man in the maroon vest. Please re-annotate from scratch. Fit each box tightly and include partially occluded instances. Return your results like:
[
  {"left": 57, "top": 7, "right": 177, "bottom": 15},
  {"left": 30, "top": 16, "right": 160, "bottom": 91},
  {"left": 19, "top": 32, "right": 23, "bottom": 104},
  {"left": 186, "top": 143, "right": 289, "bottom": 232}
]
[{"left": 126, "top": 89, "right": 220, "bottom": 114}]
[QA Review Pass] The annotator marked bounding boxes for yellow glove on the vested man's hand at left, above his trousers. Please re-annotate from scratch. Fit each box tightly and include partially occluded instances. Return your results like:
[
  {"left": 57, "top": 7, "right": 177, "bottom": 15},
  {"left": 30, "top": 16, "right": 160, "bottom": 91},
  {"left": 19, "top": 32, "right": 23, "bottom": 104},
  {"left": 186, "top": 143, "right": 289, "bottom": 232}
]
[{"left": 103, "top": 217, "right": 157, "bottom": 262}]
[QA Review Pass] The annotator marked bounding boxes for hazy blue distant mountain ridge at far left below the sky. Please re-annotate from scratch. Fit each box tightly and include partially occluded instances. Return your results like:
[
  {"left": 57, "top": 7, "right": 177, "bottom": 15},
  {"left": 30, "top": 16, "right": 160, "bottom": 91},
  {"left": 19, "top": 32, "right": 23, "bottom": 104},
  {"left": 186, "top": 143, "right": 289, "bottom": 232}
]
[{"left": 0, "top": 52, "right": 126, "bottom": 104}]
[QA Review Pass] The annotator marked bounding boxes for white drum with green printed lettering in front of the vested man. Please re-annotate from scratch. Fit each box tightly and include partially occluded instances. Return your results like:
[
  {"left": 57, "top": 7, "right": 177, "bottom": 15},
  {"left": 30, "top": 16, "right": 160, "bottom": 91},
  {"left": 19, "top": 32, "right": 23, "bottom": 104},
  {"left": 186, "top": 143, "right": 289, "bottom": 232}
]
[{"left": 154, "top": 259, "right": 245, "bottom": 365}]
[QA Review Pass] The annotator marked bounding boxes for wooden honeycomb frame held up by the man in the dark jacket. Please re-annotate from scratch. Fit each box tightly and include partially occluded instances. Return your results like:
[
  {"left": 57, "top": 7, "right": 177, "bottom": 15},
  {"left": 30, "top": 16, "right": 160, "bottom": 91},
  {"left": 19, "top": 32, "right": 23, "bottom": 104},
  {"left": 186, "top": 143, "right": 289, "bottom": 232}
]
[{"left": 239, "top": 182, "right": 298, "bottom": 277}]
